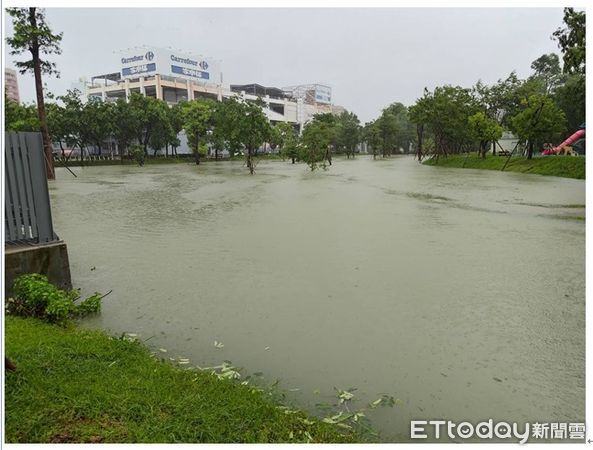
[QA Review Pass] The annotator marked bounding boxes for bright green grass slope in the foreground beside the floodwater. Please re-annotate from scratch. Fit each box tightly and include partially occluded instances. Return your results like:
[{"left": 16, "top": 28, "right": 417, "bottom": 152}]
[{"left": 5, "top": 316, "right": 361, "bottom": 443}]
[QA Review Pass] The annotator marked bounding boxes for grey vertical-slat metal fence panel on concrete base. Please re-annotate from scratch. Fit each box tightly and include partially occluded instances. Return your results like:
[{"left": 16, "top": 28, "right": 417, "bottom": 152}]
[{"left": 4, "top": 132, "right": 58, "bottom": 245}]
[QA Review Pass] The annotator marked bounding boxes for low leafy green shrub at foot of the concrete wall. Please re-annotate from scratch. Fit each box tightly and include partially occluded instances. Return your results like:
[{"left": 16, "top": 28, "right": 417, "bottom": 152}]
[{"left": 6, "top": 273, "right": 103, "bottom": 325}]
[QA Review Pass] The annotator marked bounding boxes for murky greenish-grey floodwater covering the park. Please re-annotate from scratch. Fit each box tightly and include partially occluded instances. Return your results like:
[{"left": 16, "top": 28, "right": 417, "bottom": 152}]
[{"left": 50, "top": 156, "right": 585, "bottom": 441}]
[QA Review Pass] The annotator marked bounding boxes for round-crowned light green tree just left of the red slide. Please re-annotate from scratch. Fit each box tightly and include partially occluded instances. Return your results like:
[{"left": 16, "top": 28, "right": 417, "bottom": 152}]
[{"left": 512, "top": 95, "right": 566, "bottom": 159}]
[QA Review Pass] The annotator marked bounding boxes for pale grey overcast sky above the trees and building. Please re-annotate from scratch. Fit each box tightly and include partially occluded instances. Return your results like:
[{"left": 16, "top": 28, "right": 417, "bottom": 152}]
[{"left": 5, "top": 8, "right": 563, "bottom": 122}]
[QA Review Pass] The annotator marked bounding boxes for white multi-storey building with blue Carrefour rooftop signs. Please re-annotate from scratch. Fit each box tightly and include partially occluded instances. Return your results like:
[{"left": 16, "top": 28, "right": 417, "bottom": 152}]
[{"left": 85, "top": 47, "right": 344, "bottom": 151}]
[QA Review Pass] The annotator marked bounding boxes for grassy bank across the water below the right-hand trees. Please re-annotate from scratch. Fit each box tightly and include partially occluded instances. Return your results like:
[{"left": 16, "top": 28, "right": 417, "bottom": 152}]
[{"left": 424, "top": 153, "right": 585, "bottom": 180}]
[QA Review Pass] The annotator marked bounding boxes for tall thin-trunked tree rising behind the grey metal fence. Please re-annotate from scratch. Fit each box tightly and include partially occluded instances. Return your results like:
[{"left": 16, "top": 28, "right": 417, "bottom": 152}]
[{"left": 6, "top": 7, "right": 62, "bottom": 180}]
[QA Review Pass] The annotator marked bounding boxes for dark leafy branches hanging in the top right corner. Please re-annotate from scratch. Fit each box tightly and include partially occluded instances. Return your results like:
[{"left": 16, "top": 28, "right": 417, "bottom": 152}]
[{"left": 552, "top": 8, "right": 586, "bottom": 75}]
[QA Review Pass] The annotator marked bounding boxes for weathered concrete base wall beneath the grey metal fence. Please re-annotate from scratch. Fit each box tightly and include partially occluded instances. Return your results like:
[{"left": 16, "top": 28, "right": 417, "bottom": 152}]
[{"left": 4, "top": 241, "right": 72, "bottom": 297}]
